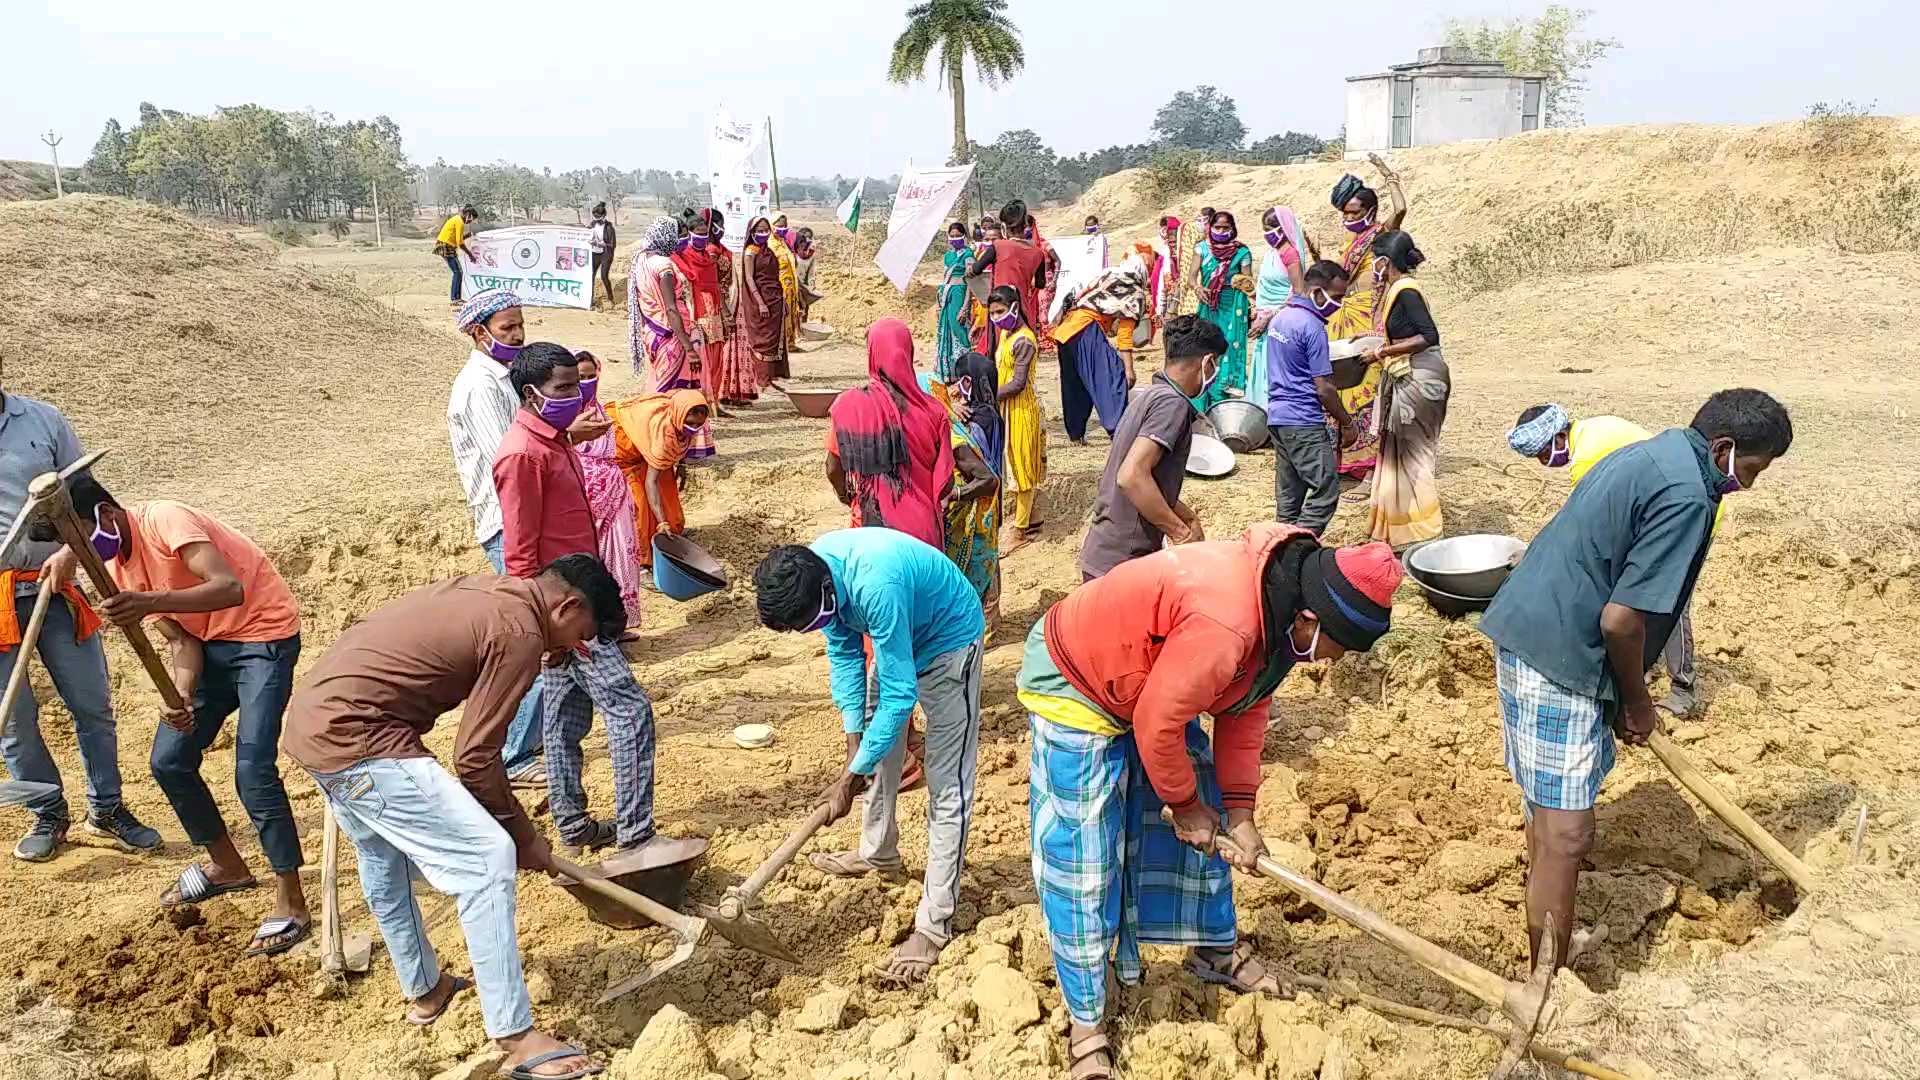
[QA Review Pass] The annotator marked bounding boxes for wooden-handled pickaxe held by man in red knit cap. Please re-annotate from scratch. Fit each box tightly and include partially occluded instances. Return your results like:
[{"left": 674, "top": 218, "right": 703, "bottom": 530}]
[{"left": 1160, "top": 809, "right": 1559, "bottom": 1080}]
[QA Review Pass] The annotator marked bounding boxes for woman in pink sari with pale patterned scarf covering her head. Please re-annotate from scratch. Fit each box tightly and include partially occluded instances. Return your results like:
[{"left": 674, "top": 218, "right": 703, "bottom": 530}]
[{"left": 626, "top": 217, "right": 714, "bottom": 461}]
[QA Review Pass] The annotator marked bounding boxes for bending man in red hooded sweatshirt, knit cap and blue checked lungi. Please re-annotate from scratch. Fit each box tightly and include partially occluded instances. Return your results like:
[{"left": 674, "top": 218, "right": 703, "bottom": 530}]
[{"left": 1020, "top": 525, "right": 1400, "bottom": 1076}]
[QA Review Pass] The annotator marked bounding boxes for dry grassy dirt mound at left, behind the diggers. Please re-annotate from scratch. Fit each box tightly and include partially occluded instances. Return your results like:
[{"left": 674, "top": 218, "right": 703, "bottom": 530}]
[{"left": 0, "top": 196, "right": 465, "bottom": 527}]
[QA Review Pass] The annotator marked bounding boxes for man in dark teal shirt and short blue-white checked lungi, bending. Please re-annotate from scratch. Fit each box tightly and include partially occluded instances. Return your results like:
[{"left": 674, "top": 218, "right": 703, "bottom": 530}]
[{"left": 1480, "top": 390, "right": 1793, "bottom": 976}]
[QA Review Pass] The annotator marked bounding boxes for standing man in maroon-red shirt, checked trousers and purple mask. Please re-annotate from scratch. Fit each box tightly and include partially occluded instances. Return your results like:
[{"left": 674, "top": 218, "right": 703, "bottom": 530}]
[{"left": 493, "top": 342, "right": 707, "bottom": 874}]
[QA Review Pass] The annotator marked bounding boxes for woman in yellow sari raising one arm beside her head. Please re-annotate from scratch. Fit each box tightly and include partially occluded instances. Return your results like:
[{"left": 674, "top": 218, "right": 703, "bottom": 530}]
[{"left": 1327, "top": 154, "right": 1407, "bottom": 480}]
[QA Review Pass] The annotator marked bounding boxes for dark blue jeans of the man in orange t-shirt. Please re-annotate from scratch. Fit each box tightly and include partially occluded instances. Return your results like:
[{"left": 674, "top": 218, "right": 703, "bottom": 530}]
[{"left": 150, "top": 634, "right": 300, "bottom": 874}]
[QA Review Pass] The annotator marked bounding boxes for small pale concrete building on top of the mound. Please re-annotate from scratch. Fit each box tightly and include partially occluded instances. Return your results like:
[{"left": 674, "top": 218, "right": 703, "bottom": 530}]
[{"left": 1346, "top": 46, "right": 1546, "bottom": 158}]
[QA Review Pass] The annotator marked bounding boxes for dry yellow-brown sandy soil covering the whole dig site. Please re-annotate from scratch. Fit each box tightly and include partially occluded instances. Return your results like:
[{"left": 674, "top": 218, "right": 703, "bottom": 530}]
[{"left": 0, "top": 123, "right": 1920, "bottom": 1080}]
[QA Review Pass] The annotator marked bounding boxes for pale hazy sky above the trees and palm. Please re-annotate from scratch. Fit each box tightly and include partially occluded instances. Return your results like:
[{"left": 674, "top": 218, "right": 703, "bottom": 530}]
[{"left": 0, "top": 0, "right": 1920, "bottom": 175}]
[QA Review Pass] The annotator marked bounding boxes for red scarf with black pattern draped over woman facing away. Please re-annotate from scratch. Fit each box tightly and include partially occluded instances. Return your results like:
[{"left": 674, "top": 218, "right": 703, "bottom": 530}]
[{"left": 833, "top": 317, "right": 954, "bottom": 548}]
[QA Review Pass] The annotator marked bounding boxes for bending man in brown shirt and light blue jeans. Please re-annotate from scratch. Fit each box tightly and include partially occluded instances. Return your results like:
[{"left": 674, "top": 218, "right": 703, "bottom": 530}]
[{"left": 280, "top": 555, "right": 626, "bottom": 1076}]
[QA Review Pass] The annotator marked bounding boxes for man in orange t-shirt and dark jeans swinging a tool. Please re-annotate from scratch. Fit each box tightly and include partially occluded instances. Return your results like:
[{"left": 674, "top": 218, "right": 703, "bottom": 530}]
[{"left": 48, "top": 473, "right": 313, "bottom": 955}]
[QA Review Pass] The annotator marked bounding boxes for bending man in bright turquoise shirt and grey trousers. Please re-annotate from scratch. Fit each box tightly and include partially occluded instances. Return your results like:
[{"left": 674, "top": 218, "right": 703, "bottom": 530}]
[{"left": 753, "top": 528, "right": 987, "bottom": 982}]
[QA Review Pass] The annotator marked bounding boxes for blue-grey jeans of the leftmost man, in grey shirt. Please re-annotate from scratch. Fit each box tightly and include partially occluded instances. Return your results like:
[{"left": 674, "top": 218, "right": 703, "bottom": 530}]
[{"left": 0, "top": 592, "right": 121, "bottom": 821}]
